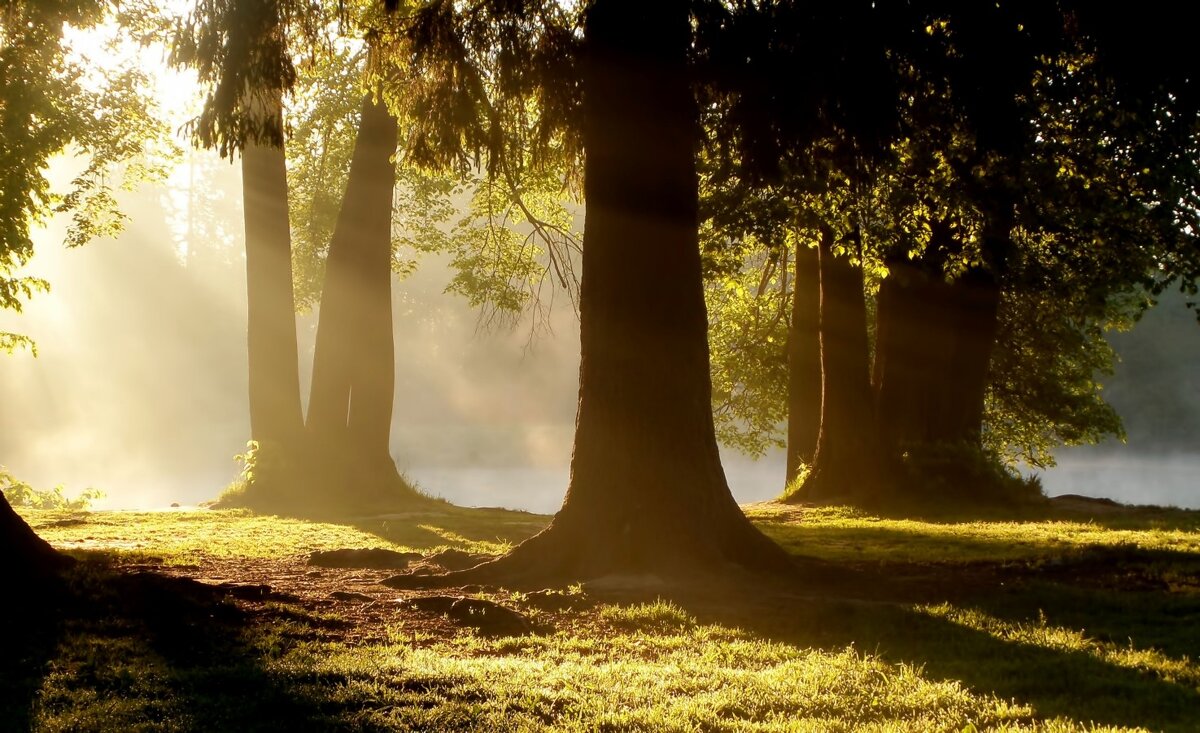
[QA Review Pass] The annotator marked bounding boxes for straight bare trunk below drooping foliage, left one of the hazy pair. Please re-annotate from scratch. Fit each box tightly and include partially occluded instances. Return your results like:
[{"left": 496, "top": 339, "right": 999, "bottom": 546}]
[{"left": 241, "top": 91, "right": 304, "bottom": 455}]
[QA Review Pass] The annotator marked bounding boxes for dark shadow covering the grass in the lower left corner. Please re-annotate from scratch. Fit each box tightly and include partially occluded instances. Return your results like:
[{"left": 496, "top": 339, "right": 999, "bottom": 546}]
[{"left": 0, "top": 564, "right": 384, "bottom": 731}]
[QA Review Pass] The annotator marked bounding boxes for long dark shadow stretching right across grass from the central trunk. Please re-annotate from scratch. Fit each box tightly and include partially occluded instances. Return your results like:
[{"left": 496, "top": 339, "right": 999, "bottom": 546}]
[{"left": 673, "top": 571, "right": 1200, "bottom": 733}]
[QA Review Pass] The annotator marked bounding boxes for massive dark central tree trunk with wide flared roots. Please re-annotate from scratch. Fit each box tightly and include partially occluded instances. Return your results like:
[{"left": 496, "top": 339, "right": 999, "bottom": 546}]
[{"left": 388, "top": 0, "right": 791, "bottom": 584}]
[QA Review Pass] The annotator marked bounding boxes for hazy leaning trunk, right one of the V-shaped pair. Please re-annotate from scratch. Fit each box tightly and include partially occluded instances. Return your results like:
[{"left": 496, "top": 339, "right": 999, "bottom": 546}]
[{"left": 307, "top": 96, "right": 415, "bottom": 503}]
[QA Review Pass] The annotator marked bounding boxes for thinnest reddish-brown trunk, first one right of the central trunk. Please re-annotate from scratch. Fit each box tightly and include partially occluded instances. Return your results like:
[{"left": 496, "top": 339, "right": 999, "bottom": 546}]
[{"left": 784, "top": 242, "right": 821, "bottom": 488}]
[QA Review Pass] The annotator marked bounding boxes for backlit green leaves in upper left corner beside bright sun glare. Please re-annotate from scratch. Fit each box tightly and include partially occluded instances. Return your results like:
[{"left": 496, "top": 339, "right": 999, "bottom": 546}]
[{"left": 0, "top": 0, "right": 175, "bottom": 352}]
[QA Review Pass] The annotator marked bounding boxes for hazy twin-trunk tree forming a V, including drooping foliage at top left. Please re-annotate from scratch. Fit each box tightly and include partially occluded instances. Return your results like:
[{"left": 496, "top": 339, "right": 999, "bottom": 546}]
[{"left": 173, "top": 1, "right": 439, "bottom": 510}]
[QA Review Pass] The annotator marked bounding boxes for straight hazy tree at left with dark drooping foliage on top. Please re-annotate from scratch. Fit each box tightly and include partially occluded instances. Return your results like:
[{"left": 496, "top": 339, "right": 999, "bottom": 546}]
[{"left": 170, "top": 0, "right": 325, "bottom": 497}]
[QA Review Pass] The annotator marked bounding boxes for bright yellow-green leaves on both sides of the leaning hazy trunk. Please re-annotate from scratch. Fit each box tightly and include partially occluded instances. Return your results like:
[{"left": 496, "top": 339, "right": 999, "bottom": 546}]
[{"left": 286, "top": 18, "right": 582, "bottom": 320}]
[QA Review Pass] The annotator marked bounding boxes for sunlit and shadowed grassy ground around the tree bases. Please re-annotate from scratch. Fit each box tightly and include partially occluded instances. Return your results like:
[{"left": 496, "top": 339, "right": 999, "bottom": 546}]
[{"left": 0, "top": 499, "right": 1200, "bottom": 732}]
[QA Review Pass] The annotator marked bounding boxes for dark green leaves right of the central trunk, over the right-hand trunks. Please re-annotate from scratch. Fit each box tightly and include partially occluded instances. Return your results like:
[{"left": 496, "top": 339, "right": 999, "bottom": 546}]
[{"left": 702, "top": 40, "right": 1200, "bottom": 465}]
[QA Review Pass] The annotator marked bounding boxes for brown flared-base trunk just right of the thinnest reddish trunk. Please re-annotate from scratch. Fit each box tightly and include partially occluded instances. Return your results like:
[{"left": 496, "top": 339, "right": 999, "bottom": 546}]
[{"left": 785, "top": 233, "right": 882, "bottom": 501}]
